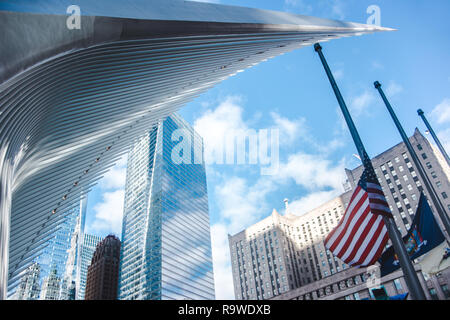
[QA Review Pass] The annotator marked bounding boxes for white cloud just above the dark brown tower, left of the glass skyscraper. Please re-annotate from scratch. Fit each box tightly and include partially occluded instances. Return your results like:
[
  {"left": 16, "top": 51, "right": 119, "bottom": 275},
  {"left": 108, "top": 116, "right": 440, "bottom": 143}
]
[{"left": 92, "top": 189, "right": 125, "bottom": 235}]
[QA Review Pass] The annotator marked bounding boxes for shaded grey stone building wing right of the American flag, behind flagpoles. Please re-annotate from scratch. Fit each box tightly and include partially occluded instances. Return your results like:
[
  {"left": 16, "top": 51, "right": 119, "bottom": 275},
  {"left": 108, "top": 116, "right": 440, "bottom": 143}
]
[{"left": 346, "top": 129, "right": 450, "bottom": 235}]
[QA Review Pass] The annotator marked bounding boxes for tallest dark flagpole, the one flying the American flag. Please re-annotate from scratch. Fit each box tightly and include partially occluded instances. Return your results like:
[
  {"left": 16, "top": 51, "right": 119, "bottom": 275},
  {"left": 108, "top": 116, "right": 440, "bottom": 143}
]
[{"left": 314, "top": 43, "right": 426, "bottom": 300}]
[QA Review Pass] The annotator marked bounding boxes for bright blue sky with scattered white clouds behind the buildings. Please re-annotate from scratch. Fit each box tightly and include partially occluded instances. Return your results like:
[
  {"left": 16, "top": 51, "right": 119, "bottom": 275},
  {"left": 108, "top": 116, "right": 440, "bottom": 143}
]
[{"left": 82, "top": 0, "right": 450, "bottom": 299}]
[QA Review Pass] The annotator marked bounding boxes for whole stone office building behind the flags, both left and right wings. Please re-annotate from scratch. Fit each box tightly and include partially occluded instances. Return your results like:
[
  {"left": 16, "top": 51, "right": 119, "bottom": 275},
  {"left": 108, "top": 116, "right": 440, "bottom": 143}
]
[{"left": 229, "top": 129, "right": 450, "bottom": 300}]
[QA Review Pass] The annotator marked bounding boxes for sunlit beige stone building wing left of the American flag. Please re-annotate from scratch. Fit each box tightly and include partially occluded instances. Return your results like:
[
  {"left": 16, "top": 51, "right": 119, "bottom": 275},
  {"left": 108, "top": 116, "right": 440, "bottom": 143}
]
[{"left": 229, "top": 193, "right": 351, "bottom": 300}]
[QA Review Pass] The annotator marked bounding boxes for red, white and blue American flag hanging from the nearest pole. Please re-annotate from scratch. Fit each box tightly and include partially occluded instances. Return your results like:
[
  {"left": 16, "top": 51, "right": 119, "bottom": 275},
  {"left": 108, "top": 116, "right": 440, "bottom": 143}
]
[{"left": 325, "top": 155, "right": 392, "bottom": 267}]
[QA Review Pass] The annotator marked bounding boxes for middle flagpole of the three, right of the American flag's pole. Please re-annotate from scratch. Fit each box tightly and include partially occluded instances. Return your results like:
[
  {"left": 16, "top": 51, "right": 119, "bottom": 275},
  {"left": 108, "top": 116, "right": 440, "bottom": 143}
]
[{"left": 374, "top": 81, "right": 450, "bottom": 240}]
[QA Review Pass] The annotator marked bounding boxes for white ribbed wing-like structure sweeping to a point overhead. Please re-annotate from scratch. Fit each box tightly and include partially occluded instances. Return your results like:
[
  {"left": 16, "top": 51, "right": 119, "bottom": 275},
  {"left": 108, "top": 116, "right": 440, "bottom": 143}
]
[{"left": 0, "top": 0, "right": 389, "bottom": 299}]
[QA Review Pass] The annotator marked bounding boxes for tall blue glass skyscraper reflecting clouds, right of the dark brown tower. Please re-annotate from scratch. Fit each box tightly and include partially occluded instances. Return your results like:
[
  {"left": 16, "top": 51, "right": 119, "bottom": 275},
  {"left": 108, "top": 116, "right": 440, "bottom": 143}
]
[{"left": 119, "top": 115, "right": 214, "bottom": 300}]
